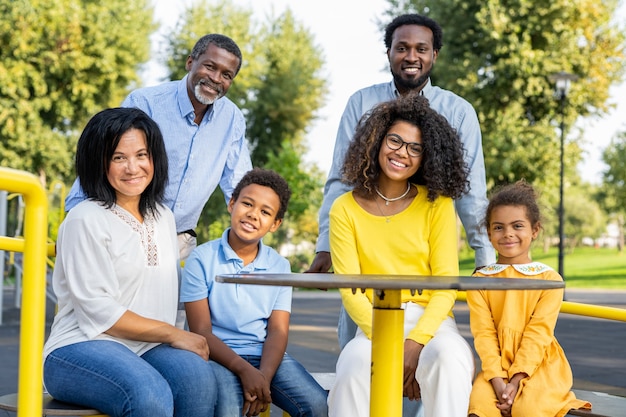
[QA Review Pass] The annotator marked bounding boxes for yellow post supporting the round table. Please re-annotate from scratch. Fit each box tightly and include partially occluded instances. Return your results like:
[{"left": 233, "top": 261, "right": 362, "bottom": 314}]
[{"left": 370, "top": 290, "right": 404, "bottom": 417}]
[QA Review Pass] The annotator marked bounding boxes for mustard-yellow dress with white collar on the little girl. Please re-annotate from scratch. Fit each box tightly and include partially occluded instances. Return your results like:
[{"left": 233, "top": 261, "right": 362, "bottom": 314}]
[{"left": 467, "top": 262, "right": 591, "bottom": 417}]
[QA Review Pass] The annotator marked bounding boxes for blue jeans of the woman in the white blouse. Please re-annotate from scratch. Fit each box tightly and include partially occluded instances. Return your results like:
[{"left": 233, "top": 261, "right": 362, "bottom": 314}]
[{"left": 44, "top": 340, "right": 217, "bottom": 417}]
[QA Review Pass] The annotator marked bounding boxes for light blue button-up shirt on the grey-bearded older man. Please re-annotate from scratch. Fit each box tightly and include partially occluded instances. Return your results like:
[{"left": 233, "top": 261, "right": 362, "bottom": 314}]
[{"left": 65, "top": 76, "right": 252, "bottom": 232}]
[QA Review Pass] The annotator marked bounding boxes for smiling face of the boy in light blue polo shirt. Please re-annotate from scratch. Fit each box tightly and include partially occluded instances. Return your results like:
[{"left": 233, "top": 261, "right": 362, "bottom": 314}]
[{"left": 228, "top": 184, "right": 282, "bottom": 249}]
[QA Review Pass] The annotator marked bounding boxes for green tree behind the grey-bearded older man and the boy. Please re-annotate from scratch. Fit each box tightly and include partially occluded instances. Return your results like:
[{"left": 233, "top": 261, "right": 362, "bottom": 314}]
[{"left": 166, "top": 0, "right": 327, "bottom": 260}]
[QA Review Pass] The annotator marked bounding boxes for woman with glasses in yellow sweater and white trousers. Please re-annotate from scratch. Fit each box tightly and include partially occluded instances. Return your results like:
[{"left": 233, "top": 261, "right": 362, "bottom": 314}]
[{"left": 328, "top": 95, "right": 474, "bottom": 417}]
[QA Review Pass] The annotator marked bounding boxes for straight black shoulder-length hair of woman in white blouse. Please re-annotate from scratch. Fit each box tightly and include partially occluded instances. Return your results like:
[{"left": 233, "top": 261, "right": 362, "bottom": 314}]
[{"left": 76, "top": 107, "right": 167, "bottom": 216}]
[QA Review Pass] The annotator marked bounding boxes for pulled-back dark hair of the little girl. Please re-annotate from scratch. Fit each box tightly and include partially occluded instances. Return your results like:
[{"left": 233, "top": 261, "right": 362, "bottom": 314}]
[{"left": 484, "top": 179, "right": 541, "bottom": 230}]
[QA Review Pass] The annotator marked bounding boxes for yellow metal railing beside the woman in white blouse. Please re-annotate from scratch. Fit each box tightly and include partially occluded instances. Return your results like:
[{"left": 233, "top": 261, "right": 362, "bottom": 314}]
[{"left": 0, "top": 167, "right": 48, "bottom": 417}]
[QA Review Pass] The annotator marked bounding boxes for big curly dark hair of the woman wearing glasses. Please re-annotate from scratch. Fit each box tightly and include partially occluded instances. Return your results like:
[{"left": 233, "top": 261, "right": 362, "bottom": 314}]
[{"left": 342, "top": 93, "right": 469, "bottom": 201}]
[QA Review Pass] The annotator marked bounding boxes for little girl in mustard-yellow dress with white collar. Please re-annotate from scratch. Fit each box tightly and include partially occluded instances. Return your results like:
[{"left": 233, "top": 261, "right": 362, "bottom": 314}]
[{"left": 467, "top": 181, "right": 591, "bottom": 417}]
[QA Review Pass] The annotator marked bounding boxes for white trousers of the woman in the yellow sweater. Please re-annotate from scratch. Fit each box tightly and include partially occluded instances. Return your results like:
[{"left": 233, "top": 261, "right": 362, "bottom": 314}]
[{"left": 328, "top": 303, "right": 474, "bottom": 417}]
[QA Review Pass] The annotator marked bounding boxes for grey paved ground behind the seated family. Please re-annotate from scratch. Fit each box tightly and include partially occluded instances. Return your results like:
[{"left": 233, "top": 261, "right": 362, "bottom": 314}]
[{"left": 0, "top": 288, "right": 626, "bottom": 417}]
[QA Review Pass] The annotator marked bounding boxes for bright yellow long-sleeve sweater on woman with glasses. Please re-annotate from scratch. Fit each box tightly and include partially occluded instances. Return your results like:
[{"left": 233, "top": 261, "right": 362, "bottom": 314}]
[{"left": 330, "top": 186, "right": 459, "bottom": 345}]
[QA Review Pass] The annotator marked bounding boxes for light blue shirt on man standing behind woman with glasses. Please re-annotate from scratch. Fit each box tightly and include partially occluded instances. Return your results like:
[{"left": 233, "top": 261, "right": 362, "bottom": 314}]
[{"left": 316, "top": 79, "right": 495, "bottom": 266}]
